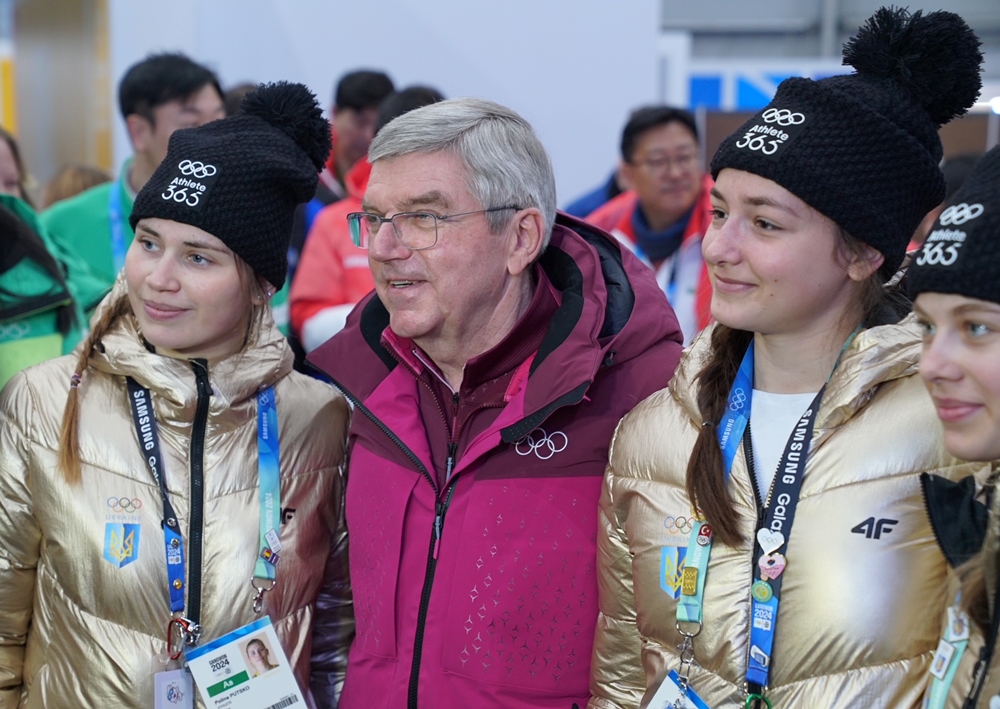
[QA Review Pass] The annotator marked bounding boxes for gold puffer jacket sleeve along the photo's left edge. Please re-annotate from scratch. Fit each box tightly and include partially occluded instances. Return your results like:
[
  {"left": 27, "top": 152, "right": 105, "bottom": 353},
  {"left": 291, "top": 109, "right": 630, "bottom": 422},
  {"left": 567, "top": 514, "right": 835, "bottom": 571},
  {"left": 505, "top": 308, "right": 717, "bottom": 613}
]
[{"left": 0, "top": 374, "right": 41, "bottom": 709}]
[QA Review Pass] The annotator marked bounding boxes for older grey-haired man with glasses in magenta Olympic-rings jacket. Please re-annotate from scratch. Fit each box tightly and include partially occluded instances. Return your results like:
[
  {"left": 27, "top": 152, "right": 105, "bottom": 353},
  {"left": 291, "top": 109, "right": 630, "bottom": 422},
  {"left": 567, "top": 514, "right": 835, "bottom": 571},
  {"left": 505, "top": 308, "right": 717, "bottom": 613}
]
[{"left": 310, "top": 99, "right": 681, "bottom": 709}]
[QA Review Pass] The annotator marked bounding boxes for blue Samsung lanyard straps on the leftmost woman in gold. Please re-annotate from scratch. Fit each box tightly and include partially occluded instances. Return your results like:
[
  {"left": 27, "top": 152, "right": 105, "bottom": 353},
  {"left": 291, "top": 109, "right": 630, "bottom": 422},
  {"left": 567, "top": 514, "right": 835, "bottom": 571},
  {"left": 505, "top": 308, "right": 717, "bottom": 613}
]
[{"left": 126, "top": 377, "right": 281, "bottom": 645}]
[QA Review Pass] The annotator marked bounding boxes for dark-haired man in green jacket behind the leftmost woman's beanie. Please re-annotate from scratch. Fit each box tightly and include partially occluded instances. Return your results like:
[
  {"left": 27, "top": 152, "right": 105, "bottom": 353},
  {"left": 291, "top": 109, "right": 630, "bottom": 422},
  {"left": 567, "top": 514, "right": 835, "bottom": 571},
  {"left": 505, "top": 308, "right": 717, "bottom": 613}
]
[{"left": 41, "top": 49, "right": 225, "bottom": 304}]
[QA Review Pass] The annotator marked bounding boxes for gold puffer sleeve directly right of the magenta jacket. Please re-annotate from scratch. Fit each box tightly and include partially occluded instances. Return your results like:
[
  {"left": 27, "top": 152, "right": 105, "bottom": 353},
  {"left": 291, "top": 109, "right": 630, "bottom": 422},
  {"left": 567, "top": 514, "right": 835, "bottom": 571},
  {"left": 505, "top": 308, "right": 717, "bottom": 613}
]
[{"left": 587, "top": 423, "right": 646, "bottom": 709}]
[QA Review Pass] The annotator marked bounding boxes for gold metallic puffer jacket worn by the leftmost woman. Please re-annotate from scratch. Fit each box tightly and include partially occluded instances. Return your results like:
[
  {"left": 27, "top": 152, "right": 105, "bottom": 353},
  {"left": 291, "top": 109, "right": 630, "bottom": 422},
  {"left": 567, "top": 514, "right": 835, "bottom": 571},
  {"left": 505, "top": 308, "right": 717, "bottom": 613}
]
[{"left": 0, "top": 290, "right": 353, "bottom": 709}]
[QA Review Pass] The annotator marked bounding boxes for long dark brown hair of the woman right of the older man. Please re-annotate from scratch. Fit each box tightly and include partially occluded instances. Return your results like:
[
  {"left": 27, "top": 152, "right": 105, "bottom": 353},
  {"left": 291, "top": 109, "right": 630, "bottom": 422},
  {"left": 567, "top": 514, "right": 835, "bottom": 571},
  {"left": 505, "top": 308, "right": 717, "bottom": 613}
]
[{"left": 687, "top": 230, "right": 910, "bottom": 546}]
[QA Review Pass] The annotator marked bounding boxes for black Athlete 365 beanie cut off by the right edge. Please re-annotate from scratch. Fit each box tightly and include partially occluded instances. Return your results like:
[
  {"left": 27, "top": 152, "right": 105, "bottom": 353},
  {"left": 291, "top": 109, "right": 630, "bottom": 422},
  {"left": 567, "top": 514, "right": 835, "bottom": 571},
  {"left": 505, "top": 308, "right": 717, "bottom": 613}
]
[{"left": 906, "top": 146, "right": 1000, "bottom": 303}]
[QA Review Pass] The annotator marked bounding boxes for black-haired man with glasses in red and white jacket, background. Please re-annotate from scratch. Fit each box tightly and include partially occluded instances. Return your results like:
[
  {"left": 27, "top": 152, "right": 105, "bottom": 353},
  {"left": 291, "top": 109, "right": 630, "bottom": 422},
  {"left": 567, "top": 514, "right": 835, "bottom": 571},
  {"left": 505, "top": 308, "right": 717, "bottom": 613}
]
[{"left": 587, "top": 106, "right": 712, "bottom": 344}]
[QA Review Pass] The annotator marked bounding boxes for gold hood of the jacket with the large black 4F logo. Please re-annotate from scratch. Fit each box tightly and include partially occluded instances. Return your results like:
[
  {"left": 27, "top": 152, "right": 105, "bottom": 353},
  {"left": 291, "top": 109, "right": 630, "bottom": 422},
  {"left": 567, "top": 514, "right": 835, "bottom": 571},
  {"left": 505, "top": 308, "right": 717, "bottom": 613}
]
[{"left": 670, "top": 315, "right": 921, "bottom": 446}]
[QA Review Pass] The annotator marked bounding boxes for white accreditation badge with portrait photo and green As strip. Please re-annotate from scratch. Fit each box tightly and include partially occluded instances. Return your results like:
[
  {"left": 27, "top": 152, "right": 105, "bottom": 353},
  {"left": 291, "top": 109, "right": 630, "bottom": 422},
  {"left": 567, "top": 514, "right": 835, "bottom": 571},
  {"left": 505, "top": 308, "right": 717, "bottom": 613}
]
[{"left": 187, "top": 617, "right": 306, "bottom": 709}]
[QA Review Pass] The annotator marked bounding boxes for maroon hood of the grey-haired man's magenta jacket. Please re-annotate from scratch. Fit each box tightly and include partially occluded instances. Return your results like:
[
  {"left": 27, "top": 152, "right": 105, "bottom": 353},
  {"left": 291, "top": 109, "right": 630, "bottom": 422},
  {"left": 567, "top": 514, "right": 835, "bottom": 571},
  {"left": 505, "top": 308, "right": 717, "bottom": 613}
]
[{"left": 309, "top": 213, "right": 681, "bottom": 432}]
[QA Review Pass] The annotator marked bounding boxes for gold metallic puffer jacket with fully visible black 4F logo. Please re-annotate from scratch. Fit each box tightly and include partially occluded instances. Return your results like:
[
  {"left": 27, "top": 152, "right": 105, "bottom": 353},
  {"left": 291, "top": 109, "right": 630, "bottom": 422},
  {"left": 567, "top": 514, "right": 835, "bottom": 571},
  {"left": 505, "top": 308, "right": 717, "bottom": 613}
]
[{"left": 590, "top": 319, "right": 988, "bottom": 709}]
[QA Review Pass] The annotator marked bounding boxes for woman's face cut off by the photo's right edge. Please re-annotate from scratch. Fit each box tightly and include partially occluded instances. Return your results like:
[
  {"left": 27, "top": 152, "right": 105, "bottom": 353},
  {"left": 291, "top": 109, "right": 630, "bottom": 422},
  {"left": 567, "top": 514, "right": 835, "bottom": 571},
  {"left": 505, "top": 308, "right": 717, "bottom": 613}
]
[{"left": 914, "top": 293, "right": 1000, "bottom": 460}]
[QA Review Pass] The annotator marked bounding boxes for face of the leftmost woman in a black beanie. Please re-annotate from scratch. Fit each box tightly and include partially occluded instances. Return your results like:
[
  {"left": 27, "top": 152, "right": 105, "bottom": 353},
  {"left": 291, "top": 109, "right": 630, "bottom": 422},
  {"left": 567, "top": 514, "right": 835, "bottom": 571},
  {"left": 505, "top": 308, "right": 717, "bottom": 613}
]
[{"left": 125, "top": 219, "right": 251, "bottom": 360}]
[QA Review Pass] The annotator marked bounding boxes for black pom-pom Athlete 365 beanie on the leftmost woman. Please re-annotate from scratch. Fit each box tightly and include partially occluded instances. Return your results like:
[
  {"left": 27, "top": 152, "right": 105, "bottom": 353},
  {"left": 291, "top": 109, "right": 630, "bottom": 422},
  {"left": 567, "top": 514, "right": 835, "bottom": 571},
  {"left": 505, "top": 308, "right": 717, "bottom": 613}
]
[{"left": 129, "top": 82, "right": 330, "bottom": 288}]
